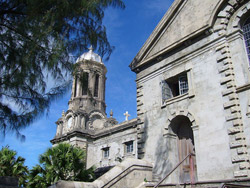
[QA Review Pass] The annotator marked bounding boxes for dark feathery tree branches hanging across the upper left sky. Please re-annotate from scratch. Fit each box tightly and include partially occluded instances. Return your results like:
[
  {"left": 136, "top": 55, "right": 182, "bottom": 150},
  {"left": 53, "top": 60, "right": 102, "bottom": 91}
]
[{"left": 0, "top": 0, "right": 124, "bottom": 138}]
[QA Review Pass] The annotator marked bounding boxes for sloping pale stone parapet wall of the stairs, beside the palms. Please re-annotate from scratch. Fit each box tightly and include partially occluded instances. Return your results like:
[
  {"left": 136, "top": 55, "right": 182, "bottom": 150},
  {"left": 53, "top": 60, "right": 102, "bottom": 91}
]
[{"left": 50, "top": 158, "right": 152, "bottom": 188}]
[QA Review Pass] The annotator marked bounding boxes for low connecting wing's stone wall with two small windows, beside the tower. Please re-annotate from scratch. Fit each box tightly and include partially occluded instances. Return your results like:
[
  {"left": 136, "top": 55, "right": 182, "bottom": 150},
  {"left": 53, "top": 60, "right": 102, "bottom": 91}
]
[{"left": 87, "top": 119, "right": 137, "bottom": 168}]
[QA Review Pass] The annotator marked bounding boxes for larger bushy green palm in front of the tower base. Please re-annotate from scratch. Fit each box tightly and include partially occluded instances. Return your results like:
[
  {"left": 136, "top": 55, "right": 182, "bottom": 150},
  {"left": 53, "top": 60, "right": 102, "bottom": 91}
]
[{"left": 28, "top": 143, "right": 94, "bottom": 188}]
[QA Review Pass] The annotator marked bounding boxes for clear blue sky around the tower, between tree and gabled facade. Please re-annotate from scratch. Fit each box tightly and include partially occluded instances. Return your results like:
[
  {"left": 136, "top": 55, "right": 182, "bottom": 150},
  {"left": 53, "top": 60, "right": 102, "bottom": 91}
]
[{"left": 0, "top": 0, "right": 173, "bottom": 168}]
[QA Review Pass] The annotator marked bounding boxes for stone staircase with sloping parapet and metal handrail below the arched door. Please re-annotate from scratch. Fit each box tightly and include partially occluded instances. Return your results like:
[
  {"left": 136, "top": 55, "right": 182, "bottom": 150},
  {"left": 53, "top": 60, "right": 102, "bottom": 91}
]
[{"left": 50, "top": 153, "right": 250, "bottom": 188}]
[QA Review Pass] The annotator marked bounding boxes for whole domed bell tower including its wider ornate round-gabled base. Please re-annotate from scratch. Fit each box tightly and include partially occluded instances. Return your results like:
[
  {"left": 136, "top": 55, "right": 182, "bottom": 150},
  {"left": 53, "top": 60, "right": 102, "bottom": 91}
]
[{"left": 51, "top": 47, "right": 113, "bottom": 149}]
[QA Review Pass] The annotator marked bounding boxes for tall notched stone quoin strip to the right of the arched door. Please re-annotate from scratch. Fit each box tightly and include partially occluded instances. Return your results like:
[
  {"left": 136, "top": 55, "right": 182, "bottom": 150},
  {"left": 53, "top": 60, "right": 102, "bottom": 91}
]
[{"left": 216, "top": 42, "right": 250, "bottom": 178}]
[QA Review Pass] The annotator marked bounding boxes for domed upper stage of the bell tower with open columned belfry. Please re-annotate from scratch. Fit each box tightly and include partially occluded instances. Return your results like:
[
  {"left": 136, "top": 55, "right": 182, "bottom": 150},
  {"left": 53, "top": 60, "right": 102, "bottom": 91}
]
[{"left": 69, "top": 46, "right": 107, "bottom": 114}]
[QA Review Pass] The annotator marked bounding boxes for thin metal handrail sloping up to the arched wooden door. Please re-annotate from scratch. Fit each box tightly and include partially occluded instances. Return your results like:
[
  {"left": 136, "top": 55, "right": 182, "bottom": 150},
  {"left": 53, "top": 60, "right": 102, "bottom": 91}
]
[{"left": 154, "top": 153, "right": 195, "bottom": 188}]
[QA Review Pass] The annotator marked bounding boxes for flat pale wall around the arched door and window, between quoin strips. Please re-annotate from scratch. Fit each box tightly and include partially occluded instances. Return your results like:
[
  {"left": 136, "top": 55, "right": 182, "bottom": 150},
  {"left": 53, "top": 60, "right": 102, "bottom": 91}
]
[{"left": 138, "top": 36, "right": 233, "bottom": 180}]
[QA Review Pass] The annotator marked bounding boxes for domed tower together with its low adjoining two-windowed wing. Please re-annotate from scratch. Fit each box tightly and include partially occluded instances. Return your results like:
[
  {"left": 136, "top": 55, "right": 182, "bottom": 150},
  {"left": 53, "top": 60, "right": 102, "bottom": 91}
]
[{"left": 51, "top": 48, "right": 137, "bottom": 169}]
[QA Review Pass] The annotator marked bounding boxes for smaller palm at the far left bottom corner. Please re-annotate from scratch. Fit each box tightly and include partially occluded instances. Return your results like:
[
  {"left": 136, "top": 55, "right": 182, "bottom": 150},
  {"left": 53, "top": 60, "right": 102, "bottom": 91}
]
[{"left": 0, "top": 146, "right": 28, "bottom": 186}]
